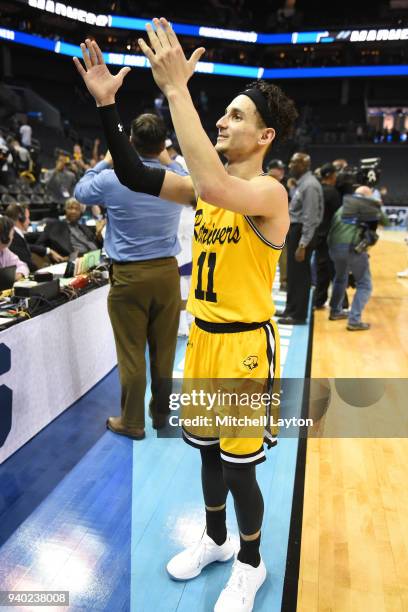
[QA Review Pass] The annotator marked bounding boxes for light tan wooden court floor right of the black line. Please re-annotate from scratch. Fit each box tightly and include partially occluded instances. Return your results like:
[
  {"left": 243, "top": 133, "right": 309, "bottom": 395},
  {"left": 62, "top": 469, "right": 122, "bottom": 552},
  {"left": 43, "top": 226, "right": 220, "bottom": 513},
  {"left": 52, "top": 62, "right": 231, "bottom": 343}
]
[{"left": 297, "top": 231, "right": 408, "bottom": 612}]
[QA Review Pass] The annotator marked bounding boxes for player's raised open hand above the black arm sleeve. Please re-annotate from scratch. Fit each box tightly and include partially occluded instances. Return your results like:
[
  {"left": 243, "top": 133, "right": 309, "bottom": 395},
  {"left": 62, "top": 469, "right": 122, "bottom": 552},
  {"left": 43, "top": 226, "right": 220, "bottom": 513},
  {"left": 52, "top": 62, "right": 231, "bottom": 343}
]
[{"left": 73, "top": 38, "right": 130, "bottom": 106}]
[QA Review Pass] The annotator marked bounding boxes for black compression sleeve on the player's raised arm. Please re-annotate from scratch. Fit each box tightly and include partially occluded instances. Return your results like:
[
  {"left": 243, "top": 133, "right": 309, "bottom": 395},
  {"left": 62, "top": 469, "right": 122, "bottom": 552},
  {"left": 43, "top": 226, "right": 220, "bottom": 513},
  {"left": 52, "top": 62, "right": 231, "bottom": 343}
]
[{"left": 98, "top": 104, "right": 166, "bottom": 196}]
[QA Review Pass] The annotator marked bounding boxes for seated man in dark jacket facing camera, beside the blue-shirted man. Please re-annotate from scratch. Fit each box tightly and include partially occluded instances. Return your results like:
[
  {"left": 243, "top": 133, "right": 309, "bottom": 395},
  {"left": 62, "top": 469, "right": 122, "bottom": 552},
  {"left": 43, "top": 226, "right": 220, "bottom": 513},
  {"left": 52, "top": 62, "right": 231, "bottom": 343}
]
[{"left": 37, "top": 198, "right": 99, "bottom": 257}]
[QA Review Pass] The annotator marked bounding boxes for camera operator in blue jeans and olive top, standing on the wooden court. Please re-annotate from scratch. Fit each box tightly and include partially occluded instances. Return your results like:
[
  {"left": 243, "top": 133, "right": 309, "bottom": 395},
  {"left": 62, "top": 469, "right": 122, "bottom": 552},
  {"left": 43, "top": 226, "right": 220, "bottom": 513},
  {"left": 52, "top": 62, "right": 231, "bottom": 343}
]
[{"left": 327, "top": 186, "right": 381, "bottom": 331}]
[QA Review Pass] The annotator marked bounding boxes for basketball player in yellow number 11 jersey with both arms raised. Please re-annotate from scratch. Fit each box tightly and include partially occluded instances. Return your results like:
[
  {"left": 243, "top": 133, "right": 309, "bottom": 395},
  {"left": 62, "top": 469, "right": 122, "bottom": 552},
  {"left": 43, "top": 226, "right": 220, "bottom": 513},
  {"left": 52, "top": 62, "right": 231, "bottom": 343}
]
[{"left": 74, "top": 18, "right": 297, "bottom": 612}]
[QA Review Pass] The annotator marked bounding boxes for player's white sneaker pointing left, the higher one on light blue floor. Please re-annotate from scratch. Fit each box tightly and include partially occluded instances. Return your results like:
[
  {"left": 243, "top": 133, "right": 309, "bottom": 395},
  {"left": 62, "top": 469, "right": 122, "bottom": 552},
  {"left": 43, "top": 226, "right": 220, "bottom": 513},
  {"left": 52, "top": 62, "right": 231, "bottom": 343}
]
[{"left": 167, "top": 533, "right": 235, "bottom": 580}]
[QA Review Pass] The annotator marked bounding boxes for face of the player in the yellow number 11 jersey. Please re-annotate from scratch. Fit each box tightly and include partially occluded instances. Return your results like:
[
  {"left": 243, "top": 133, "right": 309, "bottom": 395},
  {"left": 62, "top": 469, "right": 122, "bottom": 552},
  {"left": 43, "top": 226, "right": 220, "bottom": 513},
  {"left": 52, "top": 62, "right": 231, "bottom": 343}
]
[{"left": 215, "top": 95, "right": 264, "bottom": 161}]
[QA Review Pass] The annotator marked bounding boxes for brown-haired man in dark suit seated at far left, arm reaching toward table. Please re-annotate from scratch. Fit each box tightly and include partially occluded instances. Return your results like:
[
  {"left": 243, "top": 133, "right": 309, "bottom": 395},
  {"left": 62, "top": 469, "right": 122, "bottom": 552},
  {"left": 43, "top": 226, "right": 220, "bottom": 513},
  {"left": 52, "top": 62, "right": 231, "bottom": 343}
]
[{"left": 6, "top": 202, "right": 64, "bottom": 272}]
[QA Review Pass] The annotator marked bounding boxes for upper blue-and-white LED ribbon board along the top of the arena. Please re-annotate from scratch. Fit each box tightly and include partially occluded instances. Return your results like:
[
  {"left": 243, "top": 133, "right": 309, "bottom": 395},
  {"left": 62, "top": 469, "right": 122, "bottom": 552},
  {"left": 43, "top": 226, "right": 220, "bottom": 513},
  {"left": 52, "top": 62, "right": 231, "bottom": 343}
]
[{"left": 15, "top": 0, "right": 408, "bottom": 45}]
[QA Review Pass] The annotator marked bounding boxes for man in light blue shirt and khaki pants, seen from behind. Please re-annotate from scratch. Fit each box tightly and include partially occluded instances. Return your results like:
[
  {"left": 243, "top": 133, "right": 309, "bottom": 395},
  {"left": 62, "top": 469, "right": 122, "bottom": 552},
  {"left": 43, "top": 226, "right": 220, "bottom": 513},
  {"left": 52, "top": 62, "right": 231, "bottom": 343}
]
[{"left": 75, "top": 114, "right": 190, "bottom": 440}]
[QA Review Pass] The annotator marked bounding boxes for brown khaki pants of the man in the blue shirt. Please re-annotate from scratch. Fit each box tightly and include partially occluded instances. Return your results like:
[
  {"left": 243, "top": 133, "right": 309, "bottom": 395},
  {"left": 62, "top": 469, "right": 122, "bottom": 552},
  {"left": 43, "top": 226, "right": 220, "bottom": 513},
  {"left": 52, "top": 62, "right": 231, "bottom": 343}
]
[{"left": 108, "top": 257, "right": 180, "bottom": 428}]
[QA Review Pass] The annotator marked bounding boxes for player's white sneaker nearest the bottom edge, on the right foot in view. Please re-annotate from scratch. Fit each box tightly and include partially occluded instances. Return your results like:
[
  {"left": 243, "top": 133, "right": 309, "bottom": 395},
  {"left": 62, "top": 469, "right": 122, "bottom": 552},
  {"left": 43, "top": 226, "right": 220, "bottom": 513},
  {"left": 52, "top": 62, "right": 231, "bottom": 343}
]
[{"left": 214, "top": 559, "right": 266, "bottom": 612}]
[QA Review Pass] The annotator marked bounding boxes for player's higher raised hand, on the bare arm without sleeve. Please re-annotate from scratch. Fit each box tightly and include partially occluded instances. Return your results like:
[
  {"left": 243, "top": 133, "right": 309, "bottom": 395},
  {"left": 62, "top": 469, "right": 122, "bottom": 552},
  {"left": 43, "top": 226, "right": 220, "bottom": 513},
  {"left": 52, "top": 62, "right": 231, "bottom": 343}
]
[{"left": 138, "top": 17, "right": 205, "bottom": 96}]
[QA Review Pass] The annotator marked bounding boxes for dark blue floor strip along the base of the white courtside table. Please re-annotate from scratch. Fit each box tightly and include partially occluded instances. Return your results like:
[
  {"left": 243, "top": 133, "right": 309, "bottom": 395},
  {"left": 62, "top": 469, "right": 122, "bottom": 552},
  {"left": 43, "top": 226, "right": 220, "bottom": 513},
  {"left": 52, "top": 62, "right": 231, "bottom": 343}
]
[{"left": 0, "top": 368, "right": 119, "bottom": 547}]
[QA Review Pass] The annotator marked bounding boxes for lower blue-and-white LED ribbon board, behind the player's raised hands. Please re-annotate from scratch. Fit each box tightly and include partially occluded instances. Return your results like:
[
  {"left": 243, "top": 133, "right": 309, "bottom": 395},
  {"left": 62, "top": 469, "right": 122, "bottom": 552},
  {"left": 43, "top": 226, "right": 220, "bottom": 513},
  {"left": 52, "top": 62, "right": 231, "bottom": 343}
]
[{"left": 0, "top": 28, "right": 408, "bottom": 79}]
